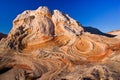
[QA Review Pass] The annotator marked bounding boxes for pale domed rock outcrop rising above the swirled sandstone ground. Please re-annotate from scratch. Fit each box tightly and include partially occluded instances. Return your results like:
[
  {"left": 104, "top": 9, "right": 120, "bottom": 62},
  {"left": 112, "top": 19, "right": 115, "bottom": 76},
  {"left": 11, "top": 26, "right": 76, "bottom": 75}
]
[{"left": 3, "top": 7, "right": 83, "bottom": 49}]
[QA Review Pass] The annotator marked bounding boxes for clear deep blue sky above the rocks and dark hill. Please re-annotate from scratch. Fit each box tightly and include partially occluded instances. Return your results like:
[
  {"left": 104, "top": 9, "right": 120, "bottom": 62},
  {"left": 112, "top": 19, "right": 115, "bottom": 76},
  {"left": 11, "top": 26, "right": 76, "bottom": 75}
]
[{"left": 0, "top": 0, "right": 120, "bottom": 33}]
